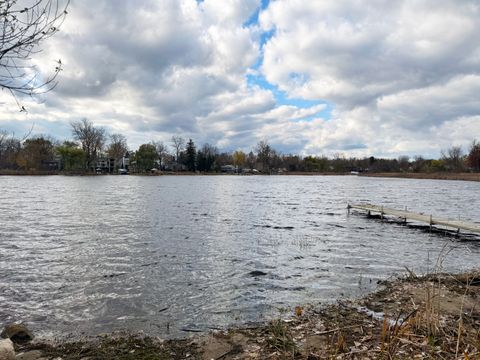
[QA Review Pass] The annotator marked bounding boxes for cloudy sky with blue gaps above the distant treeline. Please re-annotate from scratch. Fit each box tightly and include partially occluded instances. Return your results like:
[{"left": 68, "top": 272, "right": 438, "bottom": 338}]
[{"left": 0, "top": 0, "right": 480, "bottom": 158}]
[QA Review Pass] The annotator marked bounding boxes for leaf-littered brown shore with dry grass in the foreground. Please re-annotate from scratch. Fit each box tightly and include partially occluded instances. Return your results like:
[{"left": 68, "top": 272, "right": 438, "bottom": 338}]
[{"left": 0, "top": 269, "right": 480, "bottom": 360}]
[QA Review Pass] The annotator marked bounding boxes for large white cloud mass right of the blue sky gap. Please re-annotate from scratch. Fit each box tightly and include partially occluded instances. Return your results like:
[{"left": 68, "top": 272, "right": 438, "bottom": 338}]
[{"left": 260, "top": 0, "right": 480, "bottom": 156}]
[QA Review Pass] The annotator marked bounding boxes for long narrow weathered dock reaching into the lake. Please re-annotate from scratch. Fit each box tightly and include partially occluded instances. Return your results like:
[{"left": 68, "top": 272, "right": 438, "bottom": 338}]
[{"left": 347, "top": 204, "right": 480, "bottom": 233}]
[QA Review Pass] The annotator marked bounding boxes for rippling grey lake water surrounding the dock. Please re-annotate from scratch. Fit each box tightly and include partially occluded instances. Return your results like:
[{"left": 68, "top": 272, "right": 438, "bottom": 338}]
[{"left": 0, "top": 176, "right": 480, "bottom": 337}]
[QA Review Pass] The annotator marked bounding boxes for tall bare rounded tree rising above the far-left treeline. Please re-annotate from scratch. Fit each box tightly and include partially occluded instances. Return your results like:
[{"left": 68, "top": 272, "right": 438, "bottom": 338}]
[{"left": 70, "top": 119, "right": 106, "bottom": 171}]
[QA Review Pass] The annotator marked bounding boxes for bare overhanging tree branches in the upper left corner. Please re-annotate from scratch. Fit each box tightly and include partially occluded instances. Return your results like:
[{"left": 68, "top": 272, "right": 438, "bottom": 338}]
[{"left": 0, "top": 0, "right": 69, "bottom": 102}]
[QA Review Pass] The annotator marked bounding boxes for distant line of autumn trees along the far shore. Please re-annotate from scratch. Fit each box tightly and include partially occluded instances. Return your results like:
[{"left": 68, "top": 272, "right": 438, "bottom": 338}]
[{"left": 0, "top": 119, "right": 480, "bottom": 173}]
